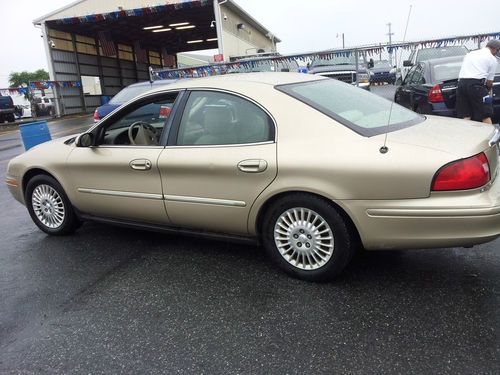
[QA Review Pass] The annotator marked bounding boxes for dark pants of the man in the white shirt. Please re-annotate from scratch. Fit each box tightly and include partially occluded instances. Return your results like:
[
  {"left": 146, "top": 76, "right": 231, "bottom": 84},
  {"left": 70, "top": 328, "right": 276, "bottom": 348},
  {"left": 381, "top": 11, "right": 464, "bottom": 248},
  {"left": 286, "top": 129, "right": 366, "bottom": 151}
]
[{"left": 456, "top": 78, "right": 493, "bottom": 121}]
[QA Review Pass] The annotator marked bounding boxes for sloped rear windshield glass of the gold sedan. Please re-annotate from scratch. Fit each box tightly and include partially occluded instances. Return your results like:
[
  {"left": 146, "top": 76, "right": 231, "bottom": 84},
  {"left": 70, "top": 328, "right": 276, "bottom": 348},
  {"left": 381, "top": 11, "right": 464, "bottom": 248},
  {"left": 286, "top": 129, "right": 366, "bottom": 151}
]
[{"left": 276, "top": 78, "right": 425, "bottom": 137}]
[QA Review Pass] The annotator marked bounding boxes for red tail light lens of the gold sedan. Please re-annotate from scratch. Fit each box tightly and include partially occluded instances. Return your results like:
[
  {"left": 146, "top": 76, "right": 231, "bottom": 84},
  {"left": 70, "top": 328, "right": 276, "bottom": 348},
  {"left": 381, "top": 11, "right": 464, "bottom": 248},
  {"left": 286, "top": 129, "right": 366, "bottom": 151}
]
[{"left": 432, "top": 153, "right": 490, "bottom": 191}]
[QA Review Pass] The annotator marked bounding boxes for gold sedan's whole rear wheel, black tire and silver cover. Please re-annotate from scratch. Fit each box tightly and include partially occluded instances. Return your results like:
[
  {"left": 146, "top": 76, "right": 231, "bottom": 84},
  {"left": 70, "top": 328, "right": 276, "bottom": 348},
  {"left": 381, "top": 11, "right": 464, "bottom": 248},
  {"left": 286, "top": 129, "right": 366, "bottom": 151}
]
[{"left": 262, "top": 193, "right": 356, "bottom": 281}]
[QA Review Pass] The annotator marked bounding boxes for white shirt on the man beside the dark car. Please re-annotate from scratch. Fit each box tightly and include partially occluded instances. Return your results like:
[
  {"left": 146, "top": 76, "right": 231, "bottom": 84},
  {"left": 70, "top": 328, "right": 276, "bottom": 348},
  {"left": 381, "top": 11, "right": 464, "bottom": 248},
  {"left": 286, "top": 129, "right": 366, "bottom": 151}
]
[{"left": 458, "top": 47, "right": 497, "bottom": 81}]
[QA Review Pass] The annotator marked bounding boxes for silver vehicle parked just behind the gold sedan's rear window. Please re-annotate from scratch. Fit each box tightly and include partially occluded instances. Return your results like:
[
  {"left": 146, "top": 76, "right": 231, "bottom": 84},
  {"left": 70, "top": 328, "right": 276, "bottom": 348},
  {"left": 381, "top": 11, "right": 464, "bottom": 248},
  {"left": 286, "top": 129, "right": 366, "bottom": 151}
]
[{"left": 308, "top": 53, "right": 372, "bottom": 90}]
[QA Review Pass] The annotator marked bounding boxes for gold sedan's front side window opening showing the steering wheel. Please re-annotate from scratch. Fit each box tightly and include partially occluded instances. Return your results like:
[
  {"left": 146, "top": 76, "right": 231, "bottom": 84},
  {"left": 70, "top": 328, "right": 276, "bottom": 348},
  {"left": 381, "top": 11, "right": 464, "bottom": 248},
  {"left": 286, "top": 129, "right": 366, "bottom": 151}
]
[{"left": 100, "top": 93, "right": 177, "bottom": 146}]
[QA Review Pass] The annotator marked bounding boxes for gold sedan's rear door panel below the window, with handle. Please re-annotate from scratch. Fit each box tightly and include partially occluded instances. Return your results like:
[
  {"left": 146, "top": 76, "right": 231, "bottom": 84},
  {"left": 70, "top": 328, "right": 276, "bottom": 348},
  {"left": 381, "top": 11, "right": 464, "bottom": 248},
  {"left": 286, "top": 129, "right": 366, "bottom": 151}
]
[{"left": 158, "top": 143, "right": 277, "bottom": 234}]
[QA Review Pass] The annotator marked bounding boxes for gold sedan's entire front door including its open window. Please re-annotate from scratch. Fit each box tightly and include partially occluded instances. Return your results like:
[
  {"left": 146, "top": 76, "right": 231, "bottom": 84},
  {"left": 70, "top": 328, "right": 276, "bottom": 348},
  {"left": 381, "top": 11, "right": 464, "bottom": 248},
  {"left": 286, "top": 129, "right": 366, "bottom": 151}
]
[{"left": 63, "top": 92, "right": 178, "bottom": 224}]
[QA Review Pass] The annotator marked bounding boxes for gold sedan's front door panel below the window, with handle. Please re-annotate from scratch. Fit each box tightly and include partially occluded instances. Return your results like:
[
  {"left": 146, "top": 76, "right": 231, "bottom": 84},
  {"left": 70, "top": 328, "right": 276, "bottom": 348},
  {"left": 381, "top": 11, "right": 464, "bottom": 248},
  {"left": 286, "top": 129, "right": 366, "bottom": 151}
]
[{"left": 68, "top": 146, "right": 169, "bottom": 224}]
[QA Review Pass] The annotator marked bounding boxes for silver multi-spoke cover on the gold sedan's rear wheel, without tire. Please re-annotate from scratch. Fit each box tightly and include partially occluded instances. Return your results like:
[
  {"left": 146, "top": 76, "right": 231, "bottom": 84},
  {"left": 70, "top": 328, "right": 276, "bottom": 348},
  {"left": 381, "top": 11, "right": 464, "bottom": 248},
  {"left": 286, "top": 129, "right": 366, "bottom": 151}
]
[{"left": 274, "top": 207, "right": 334, "bottom": 270}]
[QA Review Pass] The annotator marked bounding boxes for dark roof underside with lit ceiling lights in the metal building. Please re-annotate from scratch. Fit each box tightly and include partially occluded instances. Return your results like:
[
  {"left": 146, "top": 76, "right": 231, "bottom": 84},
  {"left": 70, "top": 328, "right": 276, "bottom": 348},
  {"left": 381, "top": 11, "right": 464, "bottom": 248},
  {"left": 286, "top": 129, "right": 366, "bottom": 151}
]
[{"left": 33, "top": 0, "right": 218, "bottom": 53}]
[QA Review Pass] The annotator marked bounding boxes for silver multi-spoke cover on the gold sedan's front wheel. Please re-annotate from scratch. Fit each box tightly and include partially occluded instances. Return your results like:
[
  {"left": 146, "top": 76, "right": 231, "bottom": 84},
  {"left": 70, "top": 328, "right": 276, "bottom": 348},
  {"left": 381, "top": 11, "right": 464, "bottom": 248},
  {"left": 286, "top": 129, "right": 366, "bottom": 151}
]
[{"left": 31, "top": 185, "right": 65, "bottom": 229}]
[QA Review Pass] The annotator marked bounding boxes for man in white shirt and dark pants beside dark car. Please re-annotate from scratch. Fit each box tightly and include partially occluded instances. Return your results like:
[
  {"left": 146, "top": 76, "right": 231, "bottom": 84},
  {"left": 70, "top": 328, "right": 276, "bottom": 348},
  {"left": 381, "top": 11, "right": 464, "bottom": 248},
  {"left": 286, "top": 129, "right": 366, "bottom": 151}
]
[{"left": 456, "top": 39, "right": 500, "bottom": 124}]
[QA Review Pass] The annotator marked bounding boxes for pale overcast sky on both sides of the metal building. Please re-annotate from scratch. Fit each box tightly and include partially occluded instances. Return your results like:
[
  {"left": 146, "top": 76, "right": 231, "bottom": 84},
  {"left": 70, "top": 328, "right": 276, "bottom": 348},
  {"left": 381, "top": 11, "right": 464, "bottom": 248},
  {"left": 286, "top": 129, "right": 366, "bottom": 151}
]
[{"left": 0, "top": 0, "right": 500, "bottom": 88}]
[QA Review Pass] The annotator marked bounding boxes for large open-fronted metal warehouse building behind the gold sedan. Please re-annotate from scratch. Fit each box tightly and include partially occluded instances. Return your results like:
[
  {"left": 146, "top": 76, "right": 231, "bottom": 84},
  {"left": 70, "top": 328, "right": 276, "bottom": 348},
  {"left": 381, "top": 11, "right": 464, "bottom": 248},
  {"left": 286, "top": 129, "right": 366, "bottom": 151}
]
[{"left": 33, "top": 0, "right": 280, "bottom": 114}]
